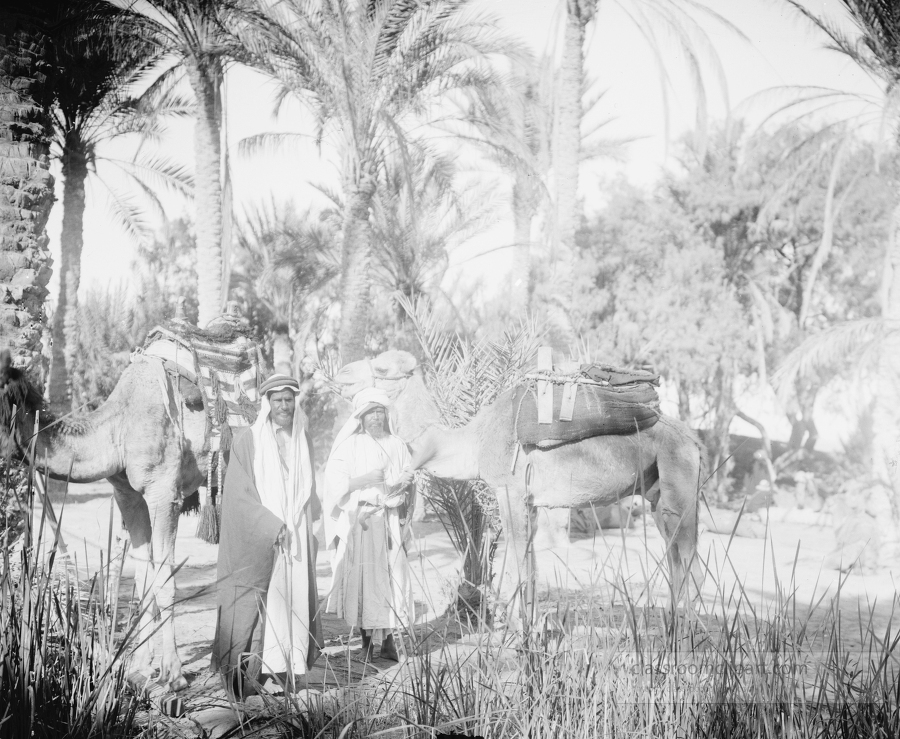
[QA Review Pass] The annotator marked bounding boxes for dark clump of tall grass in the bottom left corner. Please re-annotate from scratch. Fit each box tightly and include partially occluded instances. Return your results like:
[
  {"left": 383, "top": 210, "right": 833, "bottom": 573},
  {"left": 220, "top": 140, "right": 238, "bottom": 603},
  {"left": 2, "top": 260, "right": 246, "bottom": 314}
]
[{"left": 0, "top": 469, "right": 138, "bottom": 739}]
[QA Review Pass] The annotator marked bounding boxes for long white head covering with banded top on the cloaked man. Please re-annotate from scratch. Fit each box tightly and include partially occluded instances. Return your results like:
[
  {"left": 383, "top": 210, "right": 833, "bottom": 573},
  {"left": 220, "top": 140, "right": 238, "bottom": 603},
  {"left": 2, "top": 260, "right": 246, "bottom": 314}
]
[{"left": 251, "top": 375, "right": 314, "bottom": 554}]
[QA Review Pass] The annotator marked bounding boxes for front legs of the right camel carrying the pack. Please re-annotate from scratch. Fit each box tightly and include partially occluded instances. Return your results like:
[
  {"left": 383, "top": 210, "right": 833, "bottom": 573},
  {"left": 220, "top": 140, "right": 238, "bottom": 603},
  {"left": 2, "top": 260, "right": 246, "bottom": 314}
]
[{"left": 497, "top": 485, "right": 535, "bottom": 629}]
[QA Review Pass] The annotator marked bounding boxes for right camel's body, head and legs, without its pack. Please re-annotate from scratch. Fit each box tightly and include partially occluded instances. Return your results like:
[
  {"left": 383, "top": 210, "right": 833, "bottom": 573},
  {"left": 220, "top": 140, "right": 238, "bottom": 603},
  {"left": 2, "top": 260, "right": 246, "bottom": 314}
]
[{"left": 334, "top": 350, "right": 706, "bottom": 623}]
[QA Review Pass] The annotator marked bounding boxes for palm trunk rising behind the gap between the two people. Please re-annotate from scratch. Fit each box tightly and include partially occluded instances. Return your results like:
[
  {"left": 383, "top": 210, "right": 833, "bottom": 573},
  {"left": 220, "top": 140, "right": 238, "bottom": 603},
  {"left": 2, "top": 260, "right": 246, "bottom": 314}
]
[{"left": 338, "top": 175, "right": 375, "bottom": 364}]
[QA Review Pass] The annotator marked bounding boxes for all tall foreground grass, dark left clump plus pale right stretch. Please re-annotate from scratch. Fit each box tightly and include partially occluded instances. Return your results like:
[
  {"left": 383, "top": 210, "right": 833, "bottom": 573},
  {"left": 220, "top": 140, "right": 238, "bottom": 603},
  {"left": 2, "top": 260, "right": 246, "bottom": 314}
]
[{"left": 0, "top": 440, "right": 900, "bottom": 739}]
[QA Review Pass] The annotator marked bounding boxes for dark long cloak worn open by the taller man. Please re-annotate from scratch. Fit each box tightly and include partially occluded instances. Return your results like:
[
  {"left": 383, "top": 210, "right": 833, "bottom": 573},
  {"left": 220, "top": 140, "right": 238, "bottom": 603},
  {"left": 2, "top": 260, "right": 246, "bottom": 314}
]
[{"left": 212, "top": 428, "right": 322, "bottom": 700}]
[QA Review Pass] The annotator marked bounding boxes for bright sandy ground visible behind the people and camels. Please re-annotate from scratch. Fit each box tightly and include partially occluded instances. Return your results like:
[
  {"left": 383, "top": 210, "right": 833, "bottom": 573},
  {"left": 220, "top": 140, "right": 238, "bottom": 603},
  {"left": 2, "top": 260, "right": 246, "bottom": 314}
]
[{"left": 24, "top": 482, "right": 900, "bottom": 728}]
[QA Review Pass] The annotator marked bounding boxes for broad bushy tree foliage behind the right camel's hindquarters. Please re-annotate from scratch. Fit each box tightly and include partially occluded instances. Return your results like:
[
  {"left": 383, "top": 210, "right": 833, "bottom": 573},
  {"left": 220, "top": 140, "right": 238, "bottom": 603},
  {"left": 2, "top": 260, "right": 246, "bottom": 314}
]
[{"left": 576, "top": 127, "right": 893, "bottom": 498}]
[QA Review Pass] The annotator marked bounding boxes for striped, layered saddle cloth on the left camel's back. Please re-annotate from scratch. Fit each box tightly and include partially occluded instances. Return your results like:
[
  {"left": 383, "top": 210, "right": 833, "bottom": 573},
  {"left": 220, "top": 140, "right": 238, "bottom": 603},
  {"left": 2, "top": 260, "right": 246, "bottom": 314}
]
[{"left": 143, "top": 323, "right": 262, "bottom": 451}]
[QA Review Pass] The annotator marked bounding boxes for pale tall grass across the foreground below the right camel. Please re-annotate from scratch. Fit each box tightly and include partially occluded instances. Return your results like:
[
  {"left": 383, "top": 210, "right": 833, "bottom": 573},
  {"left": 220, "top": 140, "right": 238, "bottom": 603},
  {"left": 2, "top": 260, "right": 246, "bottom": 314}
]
[{"left": 295, "top": 540, "right": 900, "bottom": 739}]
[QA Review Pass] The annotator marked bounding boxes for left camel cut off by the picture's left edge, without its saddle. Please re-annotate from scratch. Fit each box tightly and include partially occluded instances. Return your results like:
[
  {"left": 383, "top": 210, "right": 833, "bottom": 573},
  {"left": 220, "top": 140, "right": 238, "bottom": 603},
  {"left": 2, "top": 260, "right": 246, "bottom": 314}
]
[{"left": 0, "top": 350, "right": 210, "bottom": 690}]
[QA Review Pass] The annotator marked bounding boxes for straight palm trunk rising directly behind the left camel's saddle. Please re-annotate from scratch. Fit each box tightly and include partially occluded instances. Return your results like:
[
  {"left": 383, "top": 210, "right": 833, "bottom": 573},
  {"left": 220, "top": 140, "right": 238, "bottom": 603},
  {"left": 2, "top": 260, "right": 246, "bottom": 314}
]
[{"left": 186, "top": 58, "right": 224, "bottom": 327}]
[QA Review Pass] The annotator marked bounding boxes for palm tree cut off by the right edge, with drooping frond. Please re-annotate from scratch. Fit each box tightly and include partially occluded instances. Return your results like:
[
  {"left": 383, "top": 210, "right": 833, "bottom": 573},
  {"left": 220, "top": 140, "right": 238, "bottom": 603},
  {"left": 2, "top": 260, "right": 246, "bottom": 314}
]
[{"left": 782, "top": 0, "right": 900, "bottom": 548}]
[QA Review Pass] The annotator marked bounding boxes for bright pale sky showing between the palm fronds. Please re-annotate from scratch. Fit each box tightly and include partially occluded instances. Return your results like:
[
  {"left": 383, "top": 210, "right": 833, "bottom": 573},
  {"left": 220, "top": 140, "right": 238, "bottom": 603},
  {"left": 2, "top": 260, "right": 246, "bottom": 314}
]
[{"left": 49, "top": 0, "right": 877, "bottom": 306}]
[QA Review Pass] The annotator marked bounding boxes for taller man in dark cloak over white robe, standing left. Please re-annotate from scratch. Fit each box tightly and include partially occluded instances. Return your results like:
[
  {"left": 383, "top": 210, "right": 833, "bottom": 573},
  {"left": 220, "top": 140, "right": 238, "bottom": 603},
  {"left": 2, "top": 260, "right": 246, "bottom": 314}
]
[{"left": 212, "top": 374, "right": 322, "bottom": 700}]
